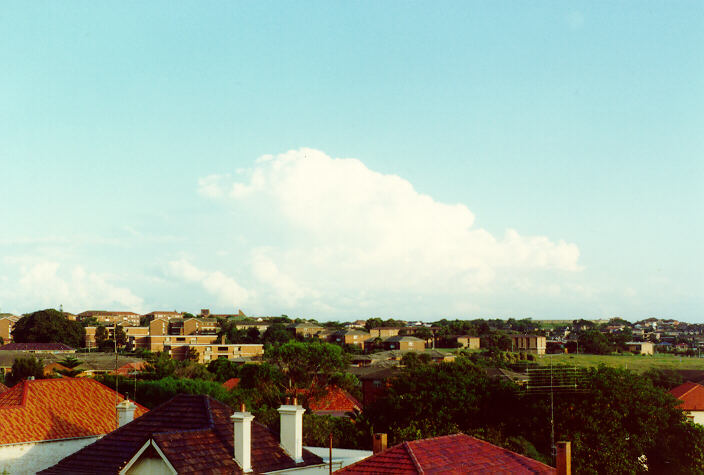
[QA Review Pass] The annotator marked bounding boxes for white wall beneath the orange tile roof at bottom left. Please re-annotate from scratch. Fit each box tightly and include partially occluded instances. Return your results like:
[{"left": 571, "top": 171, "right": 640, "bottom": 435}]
[{"left": 0, "top": 437, "right": 100, "bottom": 475}]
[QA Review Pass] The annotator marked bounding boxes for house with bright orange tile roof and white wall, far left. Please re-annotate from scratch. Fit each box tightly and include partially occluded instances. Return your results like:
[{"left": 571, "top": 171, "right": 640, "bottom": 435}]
[{"left": 0, "top": 378, "right": 147, "bottom": 473}]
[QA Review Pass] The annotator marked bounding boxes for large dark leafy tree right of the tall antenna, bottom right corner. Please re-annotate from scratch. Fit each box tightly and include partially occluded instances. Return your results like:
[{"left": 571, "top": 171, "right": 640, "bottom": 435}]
[{"left": 552, "top": 365, "right": 704, "bottom": 474}]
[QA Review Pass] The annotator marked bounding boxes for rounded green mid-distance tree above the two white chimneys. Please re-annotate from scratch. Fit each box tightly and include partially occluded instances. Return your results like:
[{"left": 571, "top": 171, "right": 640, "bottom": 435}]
[{"left": 264, "top": 341, "right": 347, "bottom": 388}]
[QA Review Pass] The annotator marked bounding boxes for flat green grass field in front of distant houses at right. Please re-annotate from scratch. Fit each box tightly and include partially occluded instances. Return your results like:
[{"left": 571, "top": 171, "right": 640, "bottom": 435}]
[{"left": 537, "top": 354, "right": 704, "bottom": 372}]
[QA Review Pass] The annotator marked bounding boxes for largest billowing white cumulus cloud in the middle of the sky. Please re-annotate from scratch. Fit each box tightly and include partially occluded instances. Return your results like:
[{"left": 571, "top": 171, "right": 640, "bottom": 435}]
[{"left": 195, "top": 149, "right": 580, "bottom": 313}]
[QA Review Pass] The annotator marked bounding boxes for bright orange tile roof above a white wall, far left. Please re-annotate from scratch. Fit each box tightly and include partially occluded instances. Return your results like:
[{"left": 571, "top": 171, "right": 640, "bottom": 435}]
[{"left": 0, "top": 378, "right": 147, "bottom": 445}]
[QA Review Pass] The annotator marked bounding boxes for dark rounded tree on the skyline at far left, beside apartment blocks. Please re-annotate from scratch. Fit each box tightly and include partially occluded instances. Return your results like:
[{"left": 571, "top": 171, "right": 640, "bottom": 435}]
[{"left": 12, "top": 308, "right": 86, "bottom": 348}]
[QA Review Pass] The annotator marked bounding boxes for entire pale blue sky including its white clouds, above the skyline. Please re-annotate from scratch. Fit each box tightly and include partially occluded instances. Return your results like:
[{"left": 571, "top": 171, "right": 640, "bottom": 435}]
[{"left": 0, "top": 1, "right": 704, "bottom": 321}]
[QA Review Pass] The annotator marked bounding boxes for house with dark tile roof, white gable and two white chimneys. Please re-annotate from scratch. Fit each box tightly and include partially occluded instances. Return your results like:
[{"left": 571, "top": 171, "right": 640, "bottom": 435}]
[{"left": 41, "top": 394, "right": 368, "bottom": 474}]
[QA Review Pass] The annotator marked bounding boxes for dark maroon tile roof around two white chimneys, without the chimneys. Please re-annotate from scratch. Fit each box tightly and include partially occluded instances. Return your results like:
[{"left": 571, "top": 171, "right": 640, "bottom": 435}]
[{"left": 41, "top": 394, "right": 322, "bottom": 474}]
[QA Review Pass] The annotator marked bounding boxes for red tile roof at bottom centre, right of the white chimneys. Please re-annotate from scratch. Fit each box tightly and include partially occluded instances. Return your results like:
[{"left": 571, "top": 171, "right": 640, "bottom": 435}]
[{"left": 335, "top": 434, "right": 555, "bottom": 474}]
